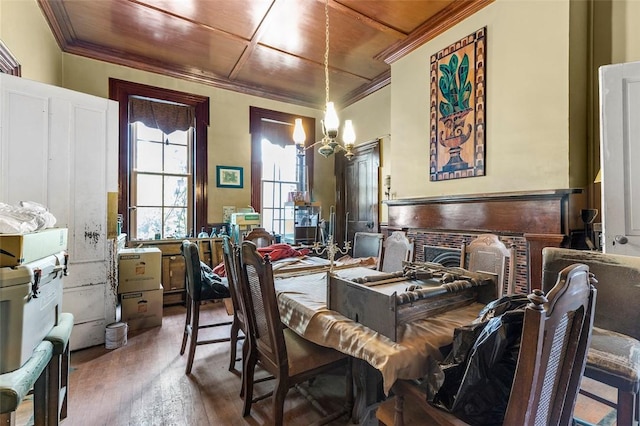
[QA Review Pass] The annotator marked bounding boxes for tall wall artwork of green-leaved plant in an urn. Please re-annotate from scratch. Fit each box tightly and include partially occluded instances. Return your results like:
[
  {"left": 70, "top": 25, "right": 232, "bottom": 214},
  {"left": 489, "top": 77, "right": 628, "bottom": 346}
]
[{"left": 429, "top": 27, "right": 487, "bottom": 181}]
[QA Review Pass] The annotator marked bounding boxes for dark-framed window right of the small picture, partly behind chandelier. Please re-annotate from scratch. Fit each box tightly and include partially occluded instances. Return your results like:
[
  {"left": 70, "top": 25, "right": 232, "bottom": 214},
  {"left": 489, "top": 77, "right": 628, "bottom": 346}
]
[{"left": 249, "top": 107, "right": 315, "bottom": 234}]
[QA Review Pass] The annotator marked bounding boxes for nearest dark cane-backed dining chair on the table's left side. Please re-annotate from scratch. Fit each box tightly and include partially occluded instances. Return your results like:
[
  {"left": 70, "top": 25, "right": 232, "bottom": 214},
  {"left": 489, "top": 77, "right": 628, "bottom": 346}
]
[{"left": 239, "top": 241, "right": 353, "bottom": 426}]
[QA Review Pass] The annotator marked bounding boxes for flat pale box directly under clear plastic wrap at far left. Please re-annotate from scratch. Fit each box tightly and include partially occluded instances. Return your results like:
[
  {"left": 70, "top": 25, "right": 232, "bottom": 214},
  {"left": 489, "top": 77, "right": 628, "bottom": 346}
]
[{"left": 0, "top": 228, "right": 67, "bottom": 267}]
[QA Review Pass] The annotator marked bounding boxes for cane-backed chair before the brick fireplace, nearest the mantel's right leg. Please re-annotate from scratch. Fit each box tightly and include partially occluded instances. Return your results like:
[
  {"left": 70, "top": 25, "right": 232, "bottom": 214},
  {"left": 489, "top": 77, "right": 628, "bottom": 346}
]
[{"left": 460, "top": 234, "right": 516, "bottom": 297}]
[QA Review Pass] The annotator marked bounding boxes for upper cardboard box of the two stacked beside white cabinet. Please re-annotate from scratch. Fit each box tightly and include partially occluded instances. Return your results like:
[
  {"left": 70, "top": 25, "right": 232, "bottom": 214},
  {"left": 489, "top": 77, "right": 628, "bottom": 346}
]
[{"left": 118, "top": 247, "right": 162, "bottom": 294}]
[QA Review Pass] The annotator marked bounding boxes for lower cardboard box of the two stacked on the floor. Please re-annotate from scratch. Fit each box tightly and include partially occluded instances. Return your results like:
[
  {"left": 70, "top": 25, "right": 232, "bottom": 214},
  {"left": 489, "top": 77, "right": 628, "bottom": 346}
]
[{"left": 120, "top": 281, "right": 164, "bottom": 331}]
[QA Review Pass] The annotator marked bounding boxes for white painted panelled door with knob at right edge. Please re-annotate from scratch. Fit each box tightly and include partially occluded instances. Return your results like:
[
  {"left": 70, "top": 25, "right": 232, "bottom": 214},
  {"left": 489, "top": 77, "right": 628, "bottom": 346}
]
[{"left": 600, "top": 62, "right": 640, "bottom": 256}]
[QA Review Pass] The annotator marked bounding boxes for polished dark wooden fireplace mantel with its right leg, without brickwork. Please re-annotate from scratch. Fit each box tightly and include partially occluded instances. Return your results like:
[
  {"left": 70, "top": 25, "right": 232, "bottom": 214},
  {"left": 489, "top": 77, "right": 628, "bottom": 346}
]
[{"left": 383, "top": 189, "right": 584, "bottom": 289}]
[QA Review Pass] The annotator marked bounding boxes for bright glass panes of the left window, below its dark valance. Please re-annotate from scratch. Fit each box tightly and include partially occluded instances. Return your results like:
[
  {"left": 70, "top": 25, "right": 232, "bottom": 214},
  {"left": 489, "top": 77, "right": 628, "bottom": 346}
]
[{"left": 130, "top": 122, "right": 193, "bottom": 240}]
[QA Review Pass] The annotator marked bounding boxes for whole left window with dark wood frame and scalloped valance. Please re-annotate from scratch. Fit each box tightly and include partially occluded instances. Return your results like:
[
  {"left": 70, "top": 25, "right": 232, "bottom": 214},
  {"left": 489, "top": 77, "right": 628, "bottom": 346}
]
[{"left": 109, "top": 78, "right": 209, "bottom": 239}]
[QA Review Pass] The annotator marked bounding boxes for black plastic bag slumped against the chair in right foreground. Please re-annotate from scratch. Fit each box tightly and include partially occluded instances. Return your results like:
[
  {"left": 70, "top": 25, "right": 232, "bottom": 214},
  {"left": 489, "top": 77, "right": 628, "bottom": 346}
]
[{"left": 431, "top": 295, "right": 528, "bottom": 425}]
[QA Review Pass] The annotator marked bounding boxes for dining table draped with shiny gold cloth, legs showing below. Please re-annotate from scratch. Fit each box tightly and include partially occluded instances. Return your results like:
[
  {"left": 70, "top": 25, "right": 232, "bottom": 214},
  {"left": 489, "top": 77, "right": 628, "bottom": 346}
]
[{"left": 274, "top": 261, "right": 485, "bottom": 423}]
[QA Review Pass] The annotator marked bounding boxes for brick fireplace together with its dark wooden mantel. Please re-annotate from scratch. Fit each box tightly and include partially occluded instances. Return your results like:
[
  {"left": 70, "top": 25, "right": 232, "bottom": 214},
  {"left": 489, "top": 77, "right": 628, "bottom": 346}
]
[{"left": 383, "top": 189, "right": 584, "bottom": 293}]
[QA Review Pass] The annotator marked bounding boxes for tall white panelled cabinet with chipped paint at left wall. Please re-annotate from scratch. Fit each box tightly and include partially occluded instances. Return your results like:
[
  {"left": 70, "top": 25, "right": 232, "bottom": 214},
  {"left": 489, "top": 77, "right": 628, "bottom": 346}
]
[{"left": 0, "top": 74, "right": 118, "bottom": 350}]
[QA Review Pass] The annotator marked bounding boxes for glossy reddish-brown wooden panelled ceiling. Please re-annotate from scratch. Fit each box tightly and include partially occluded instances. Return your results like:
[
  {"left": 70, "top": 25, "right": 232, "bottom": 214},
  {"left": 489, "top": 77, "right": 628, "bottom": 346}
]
[{"left": 38, "top": 0, "right": 493, "bottom": 109}]
